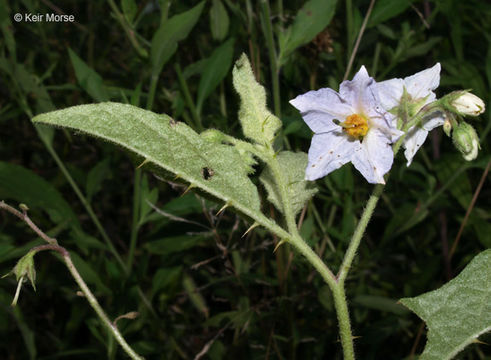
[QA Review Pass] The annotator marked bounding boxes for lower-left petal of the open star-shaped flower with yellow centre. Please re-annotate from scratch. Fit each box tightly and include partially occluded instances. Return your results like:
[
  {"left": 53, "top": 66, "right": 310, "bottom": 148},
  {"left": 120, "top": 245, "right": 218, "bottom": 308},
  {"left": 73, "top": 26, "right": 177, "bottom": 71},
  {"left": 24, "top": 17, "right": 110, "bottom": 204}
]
[{"left": 305, "top": 131, "right": 360, "bottom": 180}]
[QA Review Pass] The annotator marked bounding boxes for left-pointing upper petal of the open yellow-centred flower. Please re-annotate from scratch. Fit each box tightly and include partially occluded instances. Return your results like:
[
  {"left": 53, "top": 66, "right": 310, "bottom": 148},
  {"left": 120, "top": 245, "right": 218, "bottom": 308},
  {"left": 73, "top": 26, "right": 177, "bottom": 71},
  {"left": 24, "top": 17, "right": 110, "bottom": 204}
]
[{"left": 290, "top": 88, "right": 354, "bottom": 134}]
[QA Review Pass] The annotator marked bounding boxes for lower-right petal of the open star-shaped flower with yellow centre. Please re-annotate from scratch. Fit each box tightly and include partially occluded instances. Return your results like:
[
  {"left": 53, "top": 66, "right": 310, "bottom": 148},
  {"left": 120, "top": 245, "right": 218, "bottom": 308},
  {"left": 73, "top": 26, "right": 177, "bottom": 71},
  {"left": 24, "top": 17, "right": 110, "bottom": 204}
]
[{"left": 351, "top": 129, "right": 394, "bottom": 184}]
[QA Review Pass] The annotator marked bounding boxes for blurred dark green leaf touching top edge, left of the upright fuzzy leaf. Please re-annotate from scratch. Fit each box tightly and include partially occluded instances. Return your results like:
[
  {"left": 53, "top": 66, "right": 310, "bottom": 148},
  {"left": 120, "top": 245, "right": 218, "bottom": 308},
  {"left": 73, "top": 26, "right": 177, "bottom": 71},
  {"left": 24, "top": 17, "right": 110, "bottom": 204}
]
[{"left": 150, "top": 1, "right": 205, "bottom": 76}]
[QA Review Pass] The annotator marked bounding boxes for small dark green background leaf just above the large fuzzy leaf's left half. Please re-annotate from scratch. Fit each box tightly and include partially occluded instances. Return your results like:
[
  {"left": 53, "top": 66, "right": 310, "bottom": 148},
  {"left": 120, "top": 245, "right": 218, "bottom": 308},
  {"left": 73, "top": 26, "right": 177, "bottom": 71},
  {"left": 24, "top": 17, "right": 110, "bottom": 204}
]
[{"left": 68, "top": 49, "right": 109, "bottom": 101}]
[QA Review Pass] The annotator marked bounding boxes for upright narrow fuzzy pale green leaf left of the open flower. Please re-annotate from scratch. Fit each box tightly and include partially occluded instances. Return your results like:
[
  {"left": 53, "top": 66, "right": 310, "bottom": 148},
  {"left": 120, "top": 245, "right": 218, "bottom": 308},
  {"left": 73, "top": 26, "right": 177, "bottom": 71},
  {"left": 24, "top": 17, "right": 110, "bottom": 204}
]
[{"left": 233, "top": 54, "right": 282, "bottom": 145}]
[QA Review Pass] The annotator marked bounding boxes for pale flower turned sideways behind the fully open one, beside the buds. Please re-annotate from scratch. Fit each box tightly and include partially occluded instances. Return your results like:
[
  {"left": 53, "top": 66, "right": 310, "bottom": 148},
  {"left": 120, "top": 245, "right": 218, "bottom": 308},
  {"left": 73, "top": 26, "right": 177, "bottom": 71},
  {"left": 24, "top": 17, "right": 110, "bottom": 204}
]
[{"left": 375, "top": 63, "right": 445, "bottom": 166}]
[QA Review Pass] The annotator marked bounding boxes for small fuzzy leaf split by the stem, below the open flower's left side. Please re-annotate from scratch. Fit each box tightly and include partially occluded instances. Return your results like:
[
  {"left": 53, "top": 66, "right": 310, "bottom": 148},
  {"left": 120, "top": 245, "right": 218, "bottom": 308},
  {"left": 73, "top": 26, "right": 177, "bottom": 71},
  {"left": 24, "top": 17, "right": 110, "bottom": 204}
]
[{"left": 259, "top": 151, "right": 317, "bottom": 215}]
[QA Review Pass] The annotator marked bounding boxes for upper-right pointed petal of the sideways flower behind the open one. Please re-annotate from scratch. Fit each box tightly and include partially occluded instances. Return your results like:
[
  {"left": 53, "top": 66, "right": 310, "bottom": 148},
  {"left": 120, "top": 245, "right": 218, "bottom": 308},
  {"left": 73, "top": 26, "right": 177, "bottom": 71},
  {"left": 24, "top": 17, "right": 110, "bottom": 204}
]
[{"left": 404, "top": 63, "right": 441, "bottom": 103}]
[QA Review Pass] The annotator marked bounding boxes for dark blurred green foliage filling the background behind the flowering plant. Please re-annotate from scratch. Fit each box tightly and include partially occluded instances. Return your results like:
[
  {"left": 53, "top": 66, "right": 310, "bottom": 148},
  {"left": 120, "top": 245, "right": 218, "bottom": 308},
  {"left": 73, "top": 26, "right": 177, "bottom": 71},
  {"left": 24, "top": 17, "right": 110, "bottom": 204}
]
[{"left": 0, "top": 0, "right": 491, "bottom": 359}]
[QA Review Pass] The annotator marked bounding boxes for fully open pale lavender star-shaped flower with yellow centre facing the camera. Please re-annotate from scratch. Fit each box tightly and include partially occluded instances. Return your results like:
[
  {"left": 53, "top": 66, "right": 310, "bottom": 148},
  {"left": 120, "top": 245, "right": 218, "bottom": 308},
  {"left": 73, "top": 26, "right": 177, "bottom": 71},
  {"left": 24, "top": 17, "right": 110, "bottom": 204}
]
[{"left": 290, "top": 66, "right": 403, "bottom": 184}]
